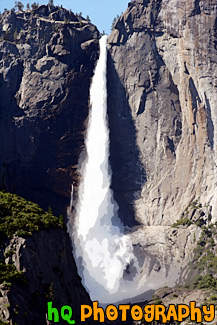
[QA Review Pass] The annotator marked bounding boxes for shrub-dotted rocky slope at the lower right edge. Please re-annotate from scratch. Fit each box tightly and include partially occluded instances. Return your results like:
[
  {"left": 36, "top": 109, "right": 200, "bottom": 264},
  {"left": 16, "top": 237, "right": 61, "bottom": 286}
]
[{"left": 147, "top": 200, "right": 217, "bottom": 316}]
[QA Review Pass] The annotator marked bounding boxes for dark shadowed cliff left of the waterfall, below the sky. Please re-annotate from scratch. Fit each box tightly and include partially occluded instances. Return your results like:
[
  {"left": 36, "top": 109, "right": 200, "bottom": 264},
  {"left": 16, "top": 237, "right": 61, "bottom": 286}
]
[{"left": 0, "top": 6, "right": 99, "bottom": 214}]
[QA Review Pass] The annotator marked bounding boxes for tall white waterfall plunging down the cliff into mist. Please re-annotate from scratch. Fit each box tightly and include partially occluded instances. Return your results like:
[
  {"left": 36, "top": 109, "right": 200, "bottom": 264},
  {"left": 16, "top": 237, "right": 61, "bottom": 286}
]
[{"left": 69, "top": 36, "right": 142, "bottom": 303}]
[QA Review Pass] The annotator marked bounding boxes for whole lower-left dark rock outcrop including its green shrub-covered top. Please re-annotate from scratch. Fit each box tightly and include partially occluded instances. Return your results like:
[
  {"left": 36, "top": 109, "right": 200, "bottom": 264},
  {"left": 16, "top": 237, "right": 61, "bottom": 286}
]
[{"left": 0, "top": 191, "right": 91, "bottom": 325}]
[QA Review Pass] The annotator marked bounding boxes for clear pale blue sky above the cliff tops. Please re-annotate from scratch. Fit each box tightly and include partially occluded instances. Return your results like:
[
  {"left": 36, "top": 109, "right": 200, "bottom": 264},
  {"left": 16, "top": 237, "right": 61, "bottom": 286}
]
[{"left": 0, "top": 0, "right": 130, "bottom": 34}]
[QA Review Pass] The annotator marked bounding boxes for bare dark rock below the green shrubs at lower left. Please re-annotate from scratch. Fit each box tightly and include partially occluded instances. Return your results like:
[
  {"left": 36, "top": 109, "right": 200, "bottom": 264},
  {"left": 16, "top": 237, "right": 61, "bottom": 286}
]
[{"left": 0, "top": 229, "right": 91, "bottom": 325}]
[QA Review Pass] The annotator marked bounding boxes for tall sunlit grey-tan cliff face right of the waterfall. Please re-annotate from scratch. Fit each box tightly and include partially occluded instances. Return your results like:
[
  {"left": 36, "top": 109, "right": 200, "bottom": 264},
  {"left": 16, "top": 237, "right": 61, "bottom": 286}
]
[{"left": 108, "top": 0, "right": 217, "bottom": 288}]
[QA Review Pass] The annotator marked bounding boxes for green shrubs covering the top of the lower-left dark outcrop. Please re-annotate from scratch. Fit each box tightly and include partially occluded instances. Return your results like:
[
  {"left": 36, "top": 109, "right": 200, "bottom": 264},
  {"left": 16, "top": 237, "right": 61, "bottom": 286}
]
[{"left": 0, "top": 191, "right": 63, "bottom": 286}]
